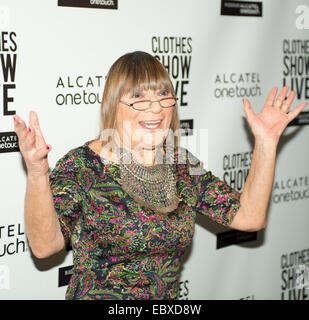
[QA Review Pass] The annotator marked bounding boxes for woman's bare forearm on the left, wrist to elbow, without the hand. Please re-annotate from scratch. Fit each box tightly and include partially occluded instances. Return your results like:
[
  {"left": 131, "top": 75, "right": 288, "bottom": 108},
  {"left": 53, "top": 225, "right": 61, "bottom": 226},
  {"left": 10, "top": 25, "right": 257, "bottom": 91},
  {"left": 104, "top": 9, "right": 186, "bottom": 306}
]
[{"left": 25, "top": 175, "right": 65, "bottom": 258}]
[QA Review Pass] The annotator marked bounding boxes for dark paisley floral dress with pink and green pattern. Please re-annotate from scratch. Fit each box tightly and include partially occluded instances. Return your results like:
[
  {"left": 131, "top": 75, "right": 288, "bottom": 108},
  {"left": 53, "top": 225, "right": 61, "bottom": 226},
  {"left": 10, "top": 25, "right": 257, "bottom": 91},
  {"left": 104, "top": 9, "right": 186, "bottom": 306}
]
[{"left": 50, "top": 141, "right": 240, "bottom": 300}]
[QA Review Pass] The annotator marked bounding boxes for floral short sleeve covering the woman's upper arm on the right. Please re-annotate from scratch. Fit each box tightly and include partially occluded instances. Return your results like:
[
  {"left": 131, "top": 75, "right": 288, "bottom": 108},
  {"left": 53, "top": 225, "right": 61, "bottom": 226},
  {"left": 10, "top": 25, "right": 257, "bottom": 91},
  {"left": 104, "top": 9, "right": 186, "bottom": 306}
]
[{"left": 184, "top": 148, "right": 240, "bottom": 226}]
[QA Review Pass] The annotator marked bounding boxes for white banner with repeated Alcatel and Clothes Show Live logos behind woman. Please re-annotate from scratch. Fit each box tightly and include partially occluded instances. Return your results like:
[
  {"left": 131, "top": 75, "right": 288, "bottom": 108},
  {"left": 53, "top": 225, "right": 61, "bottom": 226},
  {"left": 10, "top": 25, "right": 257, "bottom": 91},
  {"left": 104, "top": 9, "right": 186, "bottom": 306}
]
[{"left": 0, "top": 0, "right": 309, "bottom": 300}]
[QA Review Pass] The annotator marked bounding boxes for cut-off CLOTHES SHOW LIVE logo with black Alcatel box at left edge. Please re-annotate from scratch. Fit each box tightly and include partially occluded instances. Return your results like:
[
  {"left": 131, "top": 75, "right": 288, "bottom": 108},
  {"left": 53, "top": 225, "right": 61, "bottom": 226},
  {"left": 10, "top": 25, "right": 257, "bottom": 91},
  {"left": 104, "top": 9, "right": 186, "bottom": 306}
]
[{"left": 0, "top": 31, "right": 19, "bottom": 153}]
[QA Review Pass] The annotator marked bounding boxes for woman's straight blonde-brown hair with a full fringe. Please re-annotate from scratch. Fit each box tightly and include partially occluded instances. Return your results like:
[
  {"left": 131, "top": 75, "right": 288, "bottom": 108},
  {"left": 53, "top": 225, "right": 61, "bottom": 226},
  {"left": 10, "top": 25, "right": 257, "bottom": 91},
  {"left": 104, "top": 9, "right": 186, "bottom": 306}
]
[{"left": 98, "top": 51, "right": 180, "bottom": 147}]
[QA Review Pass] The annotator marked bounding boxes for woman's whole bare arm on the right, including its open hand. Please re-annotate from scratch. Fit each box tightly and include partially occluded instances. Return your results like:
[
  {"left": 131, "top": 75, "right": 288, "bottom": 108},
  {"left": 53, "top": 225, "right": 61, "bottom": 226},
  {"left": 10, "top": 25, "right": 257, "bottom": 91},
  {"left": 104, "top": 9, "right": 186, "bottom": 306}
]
[{"left": 230, "top": 86, "right": 307, "bottom": 231}]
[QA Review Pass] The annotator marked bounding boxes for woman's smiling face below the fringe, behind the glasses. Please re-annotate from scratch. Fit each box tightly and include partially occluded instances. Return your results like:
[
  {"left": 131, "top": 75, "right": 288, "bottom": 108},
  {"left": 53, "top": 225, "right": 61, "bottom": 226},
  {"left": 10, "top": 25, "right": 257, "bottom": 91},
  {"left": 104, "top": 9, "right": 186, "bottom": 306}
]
[{"left": 116, "top": 89, "right": 174, "bottom": 149}]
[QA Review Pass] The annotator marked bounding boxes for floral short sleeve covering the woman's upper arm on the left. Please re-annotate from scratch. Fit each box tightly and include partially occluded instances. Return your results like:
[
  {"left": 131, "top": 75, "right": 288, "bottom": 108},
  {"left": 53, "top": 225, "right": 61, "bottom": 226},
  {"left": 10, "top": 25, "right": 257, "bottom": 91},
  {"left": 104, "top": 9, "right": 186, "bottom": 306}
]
[{"left": 49, "top": 153, "right": 82, "bottom": 242}]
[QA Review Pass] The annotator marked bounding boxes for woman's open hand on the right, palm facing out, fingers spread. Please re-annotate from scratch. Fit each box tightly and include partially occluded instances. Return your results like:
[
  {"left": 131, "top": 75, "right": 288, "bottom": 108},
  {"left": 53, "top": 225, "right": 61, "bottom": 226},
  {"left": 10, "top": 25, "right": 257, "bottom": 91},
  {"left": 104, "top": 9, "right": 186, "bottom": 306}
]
[{"left": 243, "top": 86, "right": 307, "bottom": 143}]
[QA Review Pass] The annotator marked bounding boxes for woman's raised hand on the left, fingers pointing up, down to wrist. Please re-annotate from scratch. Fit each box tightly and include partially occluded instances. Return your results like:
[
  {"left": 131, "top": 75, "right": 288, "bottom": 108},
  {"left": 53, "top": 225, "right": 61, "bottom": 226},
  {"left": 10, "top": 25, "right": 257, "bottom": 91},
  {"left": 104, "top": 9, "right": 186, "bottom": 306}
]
[{"left": 13, "top": 111, "right": 51, "bottom": 176}]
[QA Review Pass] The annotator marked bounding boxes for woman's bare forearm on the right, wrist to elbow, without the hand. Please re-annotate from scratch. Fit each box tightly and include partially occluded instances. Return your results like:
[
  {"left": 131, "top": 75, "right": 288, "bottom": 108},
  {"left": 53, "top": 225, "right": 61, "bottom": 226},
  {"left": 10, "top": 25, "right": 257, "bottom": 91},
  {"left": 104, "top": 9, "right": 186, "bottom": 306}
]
[{"left": 240, "top": 140, "right": 277, "bottom": 229}]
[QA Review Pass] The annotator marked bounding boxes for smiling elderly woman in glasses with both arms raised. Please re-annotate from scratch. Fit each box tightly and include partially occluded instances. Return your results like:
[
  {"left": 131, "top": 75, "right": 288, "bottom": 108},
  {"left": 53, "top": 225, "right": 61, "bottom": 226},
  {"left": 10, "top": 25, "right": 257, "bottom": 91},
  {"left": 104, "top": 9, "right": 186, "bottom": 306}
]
[{"left": 14, "top": 52, "right": 306, "bottom": 299}]
